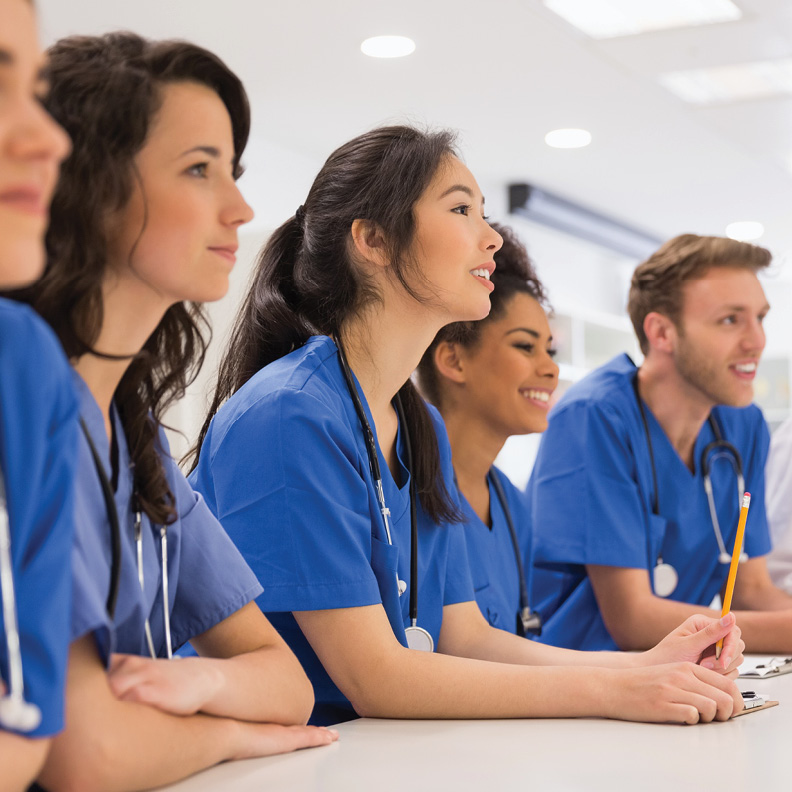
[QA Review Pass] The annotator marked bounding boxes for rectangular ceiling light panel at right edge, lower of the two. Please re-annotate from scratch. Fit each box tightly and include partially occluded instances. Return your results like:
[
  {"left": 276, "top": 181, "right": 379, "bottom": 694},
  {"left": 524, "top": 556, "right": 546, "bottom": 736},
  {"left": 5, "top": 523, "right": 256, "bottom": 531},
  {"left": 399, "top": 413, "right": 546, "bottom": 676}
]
[{"left": 658, "top": 58, "right": 792, "bottom": 104}]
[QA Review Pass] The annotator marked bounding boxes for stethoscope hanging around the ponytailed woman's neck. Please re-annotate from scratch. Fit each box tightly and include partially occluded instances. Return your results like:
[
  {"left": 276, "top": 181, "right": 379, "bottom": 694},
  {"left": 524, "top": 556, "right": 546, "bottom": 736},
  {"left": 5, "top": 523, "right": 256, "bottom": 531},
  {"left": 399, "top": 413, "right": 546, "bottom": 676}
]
[{"left": 335, "top": 338, "right": 434, "bottom": 652}]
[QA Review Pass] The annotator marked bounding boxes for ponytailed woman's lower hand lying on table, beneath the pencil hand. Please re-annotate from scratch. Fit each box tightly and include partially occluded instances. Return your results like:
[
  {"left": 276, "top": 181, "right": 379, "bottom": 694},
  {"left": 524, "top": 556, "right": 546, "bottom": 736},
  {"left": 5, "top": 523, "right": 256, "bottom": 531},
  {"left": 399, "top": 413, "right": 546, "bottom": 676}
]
[{"left": 603, "top": 663, "right": 743, "bottom": 723}]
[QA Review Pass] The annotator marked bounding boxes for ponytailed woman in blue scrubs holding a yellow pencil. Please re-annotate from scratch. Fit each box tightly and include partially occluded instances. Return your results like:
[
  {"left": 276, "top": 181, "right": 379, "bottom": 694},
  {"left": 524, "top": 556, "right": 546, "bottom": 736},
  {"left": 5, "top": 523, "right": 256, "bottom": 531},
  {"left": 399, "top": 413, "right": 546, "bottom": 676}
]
[{"left": 191, "top": 126, "right": 742, "bottom": 723}]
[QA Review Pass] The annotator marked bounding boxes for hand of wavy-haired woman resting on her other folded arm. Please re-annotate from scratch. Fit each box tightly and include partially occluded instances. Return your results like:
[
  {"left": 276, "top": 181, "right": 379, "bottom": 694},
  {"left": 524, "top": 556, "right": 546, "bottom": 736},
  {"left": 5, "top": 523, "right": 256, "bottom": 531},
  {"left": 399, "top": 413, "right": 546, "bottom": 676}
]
[{"left": 107, "top": 654, "right": 224, "bottom": 715}]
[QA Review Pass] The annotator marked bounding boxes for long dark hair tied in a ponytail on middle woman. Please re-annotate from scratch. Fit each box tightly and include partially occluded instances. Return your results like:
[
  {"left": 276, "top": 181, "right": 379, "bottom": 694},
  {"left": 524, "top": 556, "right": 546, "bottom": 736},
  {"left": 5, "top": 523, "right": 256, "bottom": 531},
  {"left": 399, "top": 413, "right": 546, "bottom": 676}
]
[{"left": 193, "top": 126, "right": 458, "bottom": 522}]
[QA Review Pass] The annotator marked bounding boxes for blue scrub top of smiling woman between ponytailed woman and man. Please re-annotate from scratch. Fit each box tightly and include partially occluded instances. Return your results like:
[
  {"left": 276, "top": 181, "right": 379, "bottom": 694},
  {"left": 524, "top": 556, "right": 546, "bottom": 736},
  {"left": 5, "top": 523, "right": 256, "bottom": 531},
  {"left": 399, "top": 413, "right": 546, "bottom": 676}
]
[{"left": 460, "top": 467, "right": 531, "bottom": 633}]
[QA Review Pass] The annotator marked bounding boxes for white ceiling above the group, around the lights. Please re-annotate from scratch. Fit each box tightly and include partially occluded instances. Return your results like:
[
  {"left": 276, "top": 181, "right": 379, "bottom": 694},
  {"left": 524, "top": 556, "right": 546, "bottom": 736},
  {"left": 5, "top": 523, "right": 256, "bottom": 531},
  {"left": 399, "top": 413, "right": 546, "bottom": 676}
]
[{"left": 37, "top": 0, "right": 792, "bottom": 258}]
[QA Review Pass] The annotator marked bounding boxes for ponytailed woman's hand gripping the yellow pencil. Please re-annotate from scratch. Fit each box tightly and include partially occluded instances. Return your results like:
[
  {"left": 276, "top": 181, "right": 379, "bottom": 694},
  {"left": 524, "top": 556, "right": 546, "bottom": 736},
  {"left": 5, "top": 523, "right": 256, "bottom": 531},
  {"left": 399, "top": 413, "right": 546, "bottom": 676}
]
[{"left": 641, "top": 613, "right": 745, "bottom": 678}]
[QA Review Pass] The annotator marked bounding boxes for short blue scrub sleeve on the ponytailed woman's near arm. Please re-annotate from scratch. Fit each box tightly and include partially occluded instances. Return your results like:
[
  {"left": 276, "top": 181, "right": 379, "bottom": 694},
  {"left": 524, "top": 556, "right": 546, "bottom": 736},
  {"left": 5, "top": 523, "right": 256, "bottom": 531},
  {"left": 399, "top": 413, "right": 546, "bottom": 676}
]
[{"left": 206, "top": 389, "right": 381, "bottom": 612}]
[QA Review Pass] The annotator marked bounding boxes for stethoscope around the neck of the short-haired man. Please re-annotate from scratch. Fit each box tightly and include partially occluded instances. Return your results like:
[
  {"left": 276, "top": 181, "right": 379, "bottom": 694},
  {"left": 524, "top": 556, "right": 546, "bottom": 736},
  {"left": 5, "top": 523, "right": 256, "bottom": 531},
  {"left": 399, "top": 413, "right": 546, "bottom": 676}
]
[{"left": 632, "top": 372, "right": 748, "bottom": 597}]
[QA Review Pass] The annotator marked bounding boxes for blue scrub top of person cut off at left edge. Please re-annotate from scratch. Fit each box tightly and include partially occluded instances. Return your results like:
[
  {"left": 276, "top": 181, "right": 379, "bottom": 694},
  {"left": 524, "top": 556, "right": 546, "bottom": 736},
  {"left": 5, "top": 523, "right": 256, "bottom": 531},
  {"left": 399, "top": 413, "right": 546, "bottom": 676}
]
[{"left": 0, "top": 299, "right": 77, "bottom": 737}]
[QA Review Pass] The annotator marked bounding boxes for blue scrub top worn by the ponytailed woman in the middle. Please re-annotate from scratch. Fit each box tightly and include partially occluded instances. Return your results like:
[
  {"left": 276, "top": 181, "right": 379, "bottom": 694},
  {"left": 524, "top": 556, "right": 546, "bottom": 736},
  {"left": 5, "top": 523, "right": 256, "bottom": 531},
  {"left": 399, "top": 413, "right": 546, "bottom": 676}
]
[{"left": 191, "top": 336, "right": 473, "bottom": 724}]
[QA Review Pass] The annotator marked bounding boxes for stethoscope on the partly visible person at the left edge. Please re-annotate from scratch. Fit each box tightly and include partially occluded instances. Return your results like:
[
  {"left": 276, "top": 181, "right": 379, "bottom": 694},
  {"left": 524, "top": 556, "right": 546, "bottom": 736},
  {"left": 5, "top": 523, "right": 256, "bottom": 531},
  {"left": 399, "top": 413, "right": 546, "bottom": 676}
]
[{"left": 0, "top": 471, "right": 41, "bottom": 732}]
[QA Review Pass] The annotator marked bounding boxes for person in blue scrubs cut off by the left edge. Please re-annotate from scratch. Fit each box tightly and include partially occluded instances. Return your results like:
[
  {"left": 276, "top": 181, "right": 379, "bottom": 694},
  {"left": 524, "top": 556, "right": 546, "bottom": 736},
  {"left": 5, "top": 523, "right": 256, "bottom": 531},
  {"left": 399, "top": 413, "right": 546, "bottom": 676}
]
[{"left": 0, "top": 0, "right": 77, "bottom": 792}]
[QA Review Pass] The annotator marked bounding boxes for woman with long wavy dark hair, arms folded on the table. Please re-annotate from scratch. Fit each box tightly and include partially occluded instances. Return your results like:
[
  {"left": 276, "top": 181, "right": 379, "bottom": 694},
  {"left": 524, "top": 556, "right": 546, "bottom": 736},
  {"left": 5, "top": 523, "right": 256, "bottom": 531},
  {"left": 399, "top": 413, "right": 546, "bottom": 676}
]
[{"left": 13, "top": 33, "right": 334, "bottom": 790}]
